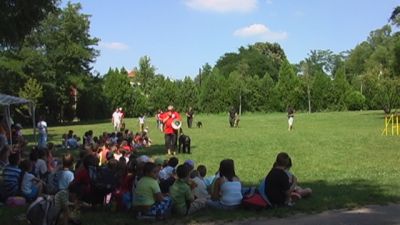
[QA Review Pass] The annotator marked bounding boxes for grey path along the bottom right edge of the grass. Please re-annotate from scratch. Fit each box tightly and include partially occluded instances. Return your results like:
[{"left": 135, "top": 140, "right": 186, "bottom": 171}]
[{"left": 190, "top": 204, "right": 400, "bottom": 225}]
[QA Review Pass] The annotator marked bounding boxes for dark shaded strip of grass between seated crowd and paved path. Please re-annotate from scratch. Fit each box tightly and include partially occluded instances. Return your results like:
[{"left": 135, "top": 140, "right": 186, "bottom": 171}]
[{"left": 188, "top": 179, "right": 400, "bottom": 221}]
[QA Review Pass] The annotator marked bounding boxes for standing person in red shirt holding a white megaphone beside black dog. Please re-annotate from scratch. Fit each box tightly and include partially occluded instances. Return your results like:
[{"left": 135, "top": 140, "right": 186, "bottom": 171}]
[{"left": 160, "top": 105, "right": 181, "bottom": 155}]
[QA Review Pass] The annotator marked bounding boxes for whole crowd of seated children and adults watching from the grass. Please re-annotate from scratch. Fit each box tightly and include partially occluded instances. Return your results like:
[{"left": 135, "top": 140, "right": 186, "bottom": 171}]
[{"left": 0, "top": 118, "right": 312, "bottom": 221}]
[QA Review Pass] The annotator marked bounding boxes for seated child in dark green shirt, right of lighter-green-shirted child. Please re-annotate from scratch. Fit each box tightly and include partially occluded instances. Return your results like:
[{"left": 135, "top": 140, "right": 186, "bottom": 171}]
[{"left": 170, "top": 164, "right": 206, "bottom": 216}]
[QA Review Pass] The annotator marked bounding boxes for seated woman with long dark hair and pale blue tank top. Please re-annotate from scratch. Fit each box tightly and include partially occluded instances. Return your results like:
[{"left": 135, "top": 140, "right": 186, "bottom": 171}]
[{"left": 207, "top": 159, "right": 243, "bottom": 209}]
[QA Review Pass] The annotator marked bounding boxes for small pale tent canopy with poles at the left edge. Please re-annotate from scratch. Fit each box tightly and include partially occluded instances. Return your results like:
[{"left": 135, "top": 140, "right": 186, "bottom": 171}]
[{"left": 0, "top": 93, "right": 36, "bottom": 144}]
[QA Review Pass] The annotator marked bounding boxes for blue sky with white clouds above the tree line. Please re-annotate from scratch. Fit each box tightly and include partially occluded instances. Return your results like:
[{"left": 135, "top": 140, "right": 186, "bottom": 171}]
[{"left": 63, "top": 0, "right": 400, "bottom": 79}]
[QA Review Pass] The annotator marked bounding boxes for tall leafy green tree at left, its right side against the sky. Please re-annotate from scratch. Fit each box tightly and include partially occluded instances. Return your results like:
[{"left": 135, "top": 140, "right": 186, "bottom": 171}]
[{"left": 21, "top": 3, "right": 98, "bottom": 120}]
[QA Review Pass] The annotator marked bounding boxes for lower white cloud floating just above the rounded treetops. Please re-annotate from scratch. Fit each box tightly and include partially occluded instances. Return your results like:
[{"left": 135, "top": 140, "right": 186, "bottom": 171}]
[{"left": 233, "top": 24, "right": 288, "bottom": 41}]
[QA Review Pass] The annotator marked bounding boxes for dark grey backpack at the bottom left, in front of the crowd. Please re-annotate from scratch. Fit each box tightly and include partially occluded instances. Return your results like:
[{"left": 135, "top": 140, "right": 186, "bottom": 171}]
[{"left": 26, "top": 195, "right": 59, "bottom": 225}]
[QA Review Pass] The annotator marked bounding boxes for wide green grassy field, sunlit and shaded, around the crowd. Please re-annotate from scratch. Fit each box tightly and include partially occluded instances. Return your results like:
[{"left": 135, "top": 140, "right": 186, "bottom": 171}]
[{"left": 0, "top": 111, "right": 400, "bottom": 225}]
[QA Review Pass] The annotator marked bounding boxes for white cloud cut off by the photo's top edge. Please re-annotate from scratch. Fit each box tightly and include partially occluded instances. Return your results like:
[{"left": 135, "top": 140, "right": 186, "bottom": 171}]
[{"left": 185, "top": 0, "right": 257, "bottom": 13}]
